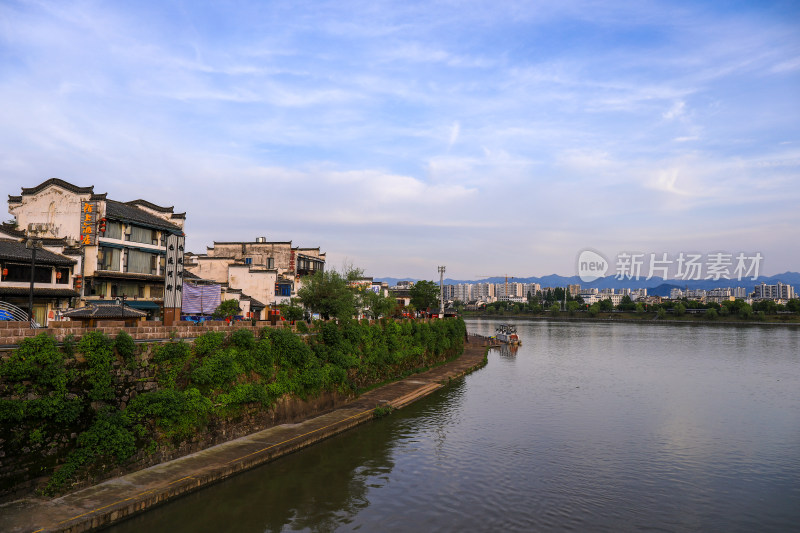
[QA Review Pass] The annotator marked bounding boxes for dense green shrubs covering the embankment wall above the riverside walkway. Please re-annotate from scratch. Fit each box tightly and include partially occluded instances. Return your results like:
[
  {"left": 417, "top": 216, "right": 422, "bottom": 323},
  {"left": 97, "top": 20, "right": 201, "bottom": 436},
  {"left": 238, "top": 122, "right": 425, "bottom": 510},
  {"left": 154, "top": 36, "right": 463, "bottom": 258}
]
[{"left": 0, "top": 319, "right": 466, "bottom": 498}]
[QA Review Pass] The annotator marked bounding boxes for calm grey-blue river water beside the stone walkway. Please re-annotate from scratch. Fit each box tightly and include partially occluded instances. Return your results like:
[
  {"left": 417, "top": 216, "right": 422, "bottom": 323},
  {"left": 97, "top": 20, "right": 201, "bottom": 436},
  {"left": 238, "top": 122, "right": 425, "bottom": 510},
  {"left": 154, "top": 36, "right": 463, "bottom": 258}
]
[{"left": 108, "top": 320, "right": 800, "bottom": 533}]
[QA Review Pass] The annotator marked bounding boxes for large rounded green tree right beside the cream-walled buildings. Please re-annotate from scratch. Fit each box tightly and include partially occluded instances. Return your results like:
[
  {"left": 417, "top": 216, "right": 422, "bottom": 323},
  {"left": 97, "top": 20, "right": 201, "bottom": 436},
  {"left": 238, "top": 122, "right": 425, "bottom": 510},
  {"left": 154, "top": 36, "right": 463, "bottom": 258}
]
[{"left": 297, "top": 269, "right": 360, "bottom": 320}]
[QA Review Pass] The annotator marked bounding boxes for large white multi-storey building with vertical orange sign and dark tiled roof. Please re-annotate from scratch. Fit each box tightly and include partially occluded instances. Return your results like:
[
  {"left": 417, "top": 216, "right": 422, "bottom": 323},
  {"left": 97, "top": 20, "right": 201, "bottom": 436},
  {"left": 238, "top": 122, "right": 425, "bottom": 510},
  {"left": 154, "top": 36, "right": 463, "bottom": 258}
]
[{"left": 8, "top": 178, "right": 186, "bottom": 318}]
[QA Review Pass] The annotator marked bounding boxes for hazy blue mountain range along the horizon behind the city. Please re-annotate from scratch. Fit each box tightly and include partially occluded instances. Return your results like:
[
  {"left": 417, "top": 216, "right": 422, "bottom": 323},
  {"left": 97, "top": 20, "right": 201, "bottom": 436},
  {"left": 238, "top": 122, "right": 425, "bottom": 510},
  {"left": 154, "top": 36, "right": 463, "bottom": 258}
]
[{"left": 375, "top": 272, "right": 800, "bottom": 296}]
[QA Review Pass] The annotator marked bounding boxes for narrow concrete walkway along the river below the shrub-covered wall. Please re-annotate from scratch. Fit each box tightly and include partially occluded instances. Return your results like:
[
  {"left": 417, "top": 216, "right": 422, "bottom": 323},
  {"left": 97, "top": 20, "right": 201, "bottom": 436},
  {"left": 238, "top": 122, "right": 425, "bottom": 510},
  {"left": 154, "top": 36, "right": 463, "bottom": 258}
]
[{"left": 0, "top": 337, "right": 487, "bottom": 533}]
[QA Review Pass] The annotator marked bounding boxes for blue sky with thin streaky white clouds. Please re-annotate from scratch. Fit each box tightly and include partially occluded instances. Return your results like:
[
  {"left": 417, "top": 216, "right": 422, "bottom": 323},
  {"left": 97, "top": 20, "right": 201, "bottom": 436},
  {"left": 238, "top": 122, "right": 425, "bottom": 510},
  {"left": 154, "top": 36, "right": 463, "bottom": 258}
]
[{"left": 0, "top": 0, "right": 800, "bottom": 279}]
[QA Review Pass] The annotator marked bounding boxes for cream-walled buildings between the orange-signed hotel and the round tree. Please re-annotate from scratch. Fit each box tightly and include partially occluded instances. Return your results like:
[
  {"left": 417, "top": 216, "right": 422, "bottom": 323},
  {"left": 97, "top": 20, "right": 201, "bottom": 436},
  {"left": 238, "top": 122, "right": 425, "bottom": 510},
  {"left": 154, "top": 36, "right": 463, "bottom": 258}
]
[{"left": 185, "top": 237, "right": 325, "bottom": 318}]
